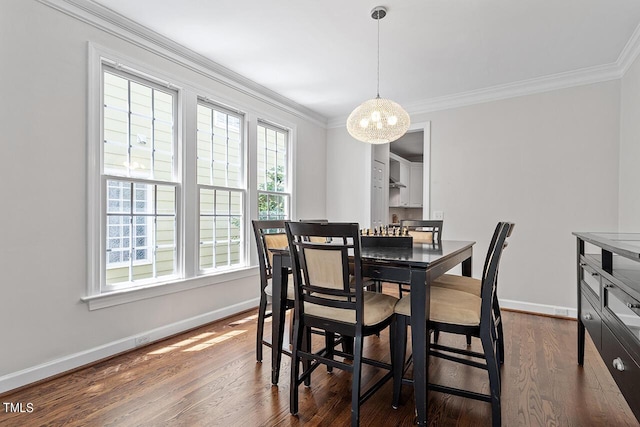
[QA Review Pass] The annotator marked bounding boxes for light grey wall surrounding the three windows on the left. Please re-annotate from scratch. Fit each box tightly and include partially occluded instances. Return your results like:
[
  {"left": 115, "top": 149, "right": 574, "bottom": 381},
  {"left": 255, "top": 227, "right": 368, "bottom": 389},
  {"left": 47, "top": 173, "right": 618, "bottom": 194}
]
[{"left": 0, "top": 0, "right": 327, "bottom": 392}]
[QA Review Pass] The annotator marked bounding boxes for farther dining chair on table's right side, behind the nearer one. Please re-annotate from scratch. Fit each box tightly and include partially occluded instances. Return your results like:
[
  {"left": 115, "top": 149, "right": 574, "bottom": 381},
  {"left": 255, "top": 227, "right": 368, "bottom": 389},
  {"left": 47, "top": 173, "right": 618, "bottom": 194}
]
[{"left": 431, "top": 221, "right": 504, "bottom": 358}]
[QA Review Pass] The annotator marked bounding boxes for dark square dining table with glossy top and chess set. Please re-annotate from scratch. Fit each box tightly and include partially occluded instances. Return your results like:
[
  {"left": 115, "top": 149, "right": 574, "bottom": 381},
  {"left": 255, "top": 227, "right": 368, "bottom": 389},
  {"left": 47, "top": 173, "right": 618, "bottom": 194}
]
[{"left": 271, "top": 240, "right": 475, "bottom": 425}]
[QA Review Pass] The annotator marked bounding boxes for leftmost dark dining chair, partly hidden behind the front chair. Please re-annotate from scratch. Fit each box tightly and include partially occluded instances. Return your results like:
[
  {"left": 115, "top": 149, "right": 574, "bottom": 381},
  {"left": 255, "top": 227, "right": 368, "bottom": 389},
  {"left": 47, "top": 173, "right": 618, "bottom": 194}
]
[{"left": 252, "top": 220, "right": 295, "bottom": 362}]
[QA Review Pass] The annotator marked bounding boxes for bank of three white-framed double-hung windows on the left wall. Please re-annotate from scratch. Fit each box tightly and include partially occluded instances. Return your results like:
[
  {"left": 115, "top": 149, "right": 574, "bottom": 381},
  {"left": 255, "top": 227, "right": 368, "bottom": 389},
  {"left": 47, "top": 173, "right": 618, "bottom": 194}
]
[{"left": 83, "top": 45, "right": 293, "bottom": 302}]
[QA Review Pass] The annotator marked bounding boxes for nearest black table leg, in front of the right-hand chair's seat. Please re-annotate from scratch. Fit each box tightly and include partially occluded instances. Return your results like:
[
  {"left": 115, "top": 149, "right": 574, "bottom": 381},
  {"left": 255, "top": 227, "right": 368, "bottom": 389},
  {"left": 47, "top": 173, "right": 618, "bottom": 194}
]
[{"left": 411, "top": 269, "right": 430, "bottom": 426}]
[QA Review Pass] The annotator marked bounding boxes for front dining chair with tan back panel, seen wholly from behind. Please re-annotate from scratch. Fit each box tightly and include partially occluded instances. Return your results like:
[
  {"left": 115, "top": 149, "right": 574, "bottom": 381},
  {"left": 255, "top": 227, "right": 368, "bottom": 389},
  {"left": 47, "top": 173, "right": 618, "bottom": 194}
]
[{"left": 285, "top": 222, "right": 398, "bottom": 426}]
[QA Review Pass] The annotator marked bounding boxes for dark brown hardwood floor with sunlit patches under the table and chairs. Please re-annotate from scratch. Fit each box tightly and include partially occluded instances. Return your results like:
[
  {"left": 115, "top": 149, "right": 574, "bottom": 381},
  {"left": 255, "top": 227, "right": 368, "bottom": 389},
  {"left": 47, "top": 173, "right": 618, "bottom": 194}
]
[{"left": 0, "top": 306, "right": 638, "bottom": 427}]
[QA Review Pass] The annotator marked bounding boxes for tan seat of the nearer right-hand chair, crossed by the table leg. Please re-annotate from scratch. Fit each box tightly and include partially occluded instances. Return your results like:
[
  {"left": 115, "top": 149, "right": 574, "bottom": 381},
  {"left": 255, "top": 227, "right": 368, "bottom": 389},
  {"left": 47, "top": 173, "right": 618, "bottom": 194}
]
[{"left": 395, "top": 286, "right": 482, "bottom": 326}]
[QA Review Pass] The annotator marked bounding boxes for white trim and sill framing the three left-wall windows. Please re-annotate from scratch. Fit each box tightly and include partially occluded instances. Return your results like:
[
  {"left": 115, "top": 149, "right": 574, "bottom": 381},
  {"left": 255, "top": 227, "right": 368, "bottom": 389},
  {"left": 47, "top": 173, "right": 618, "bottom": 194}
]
[{"left": 81, "top": 42, "right": 297, "bottom": 310}]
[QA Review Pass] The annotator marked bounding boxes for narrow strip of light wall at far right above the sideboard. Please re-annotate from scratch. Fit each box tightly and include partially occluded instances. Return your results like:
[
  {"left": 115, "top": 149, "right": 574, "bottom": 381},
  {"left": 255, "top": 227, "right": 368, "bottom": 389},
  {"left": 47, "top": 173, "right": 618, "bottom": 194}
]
[{"left": 619, "top": 52, "right": 640, "bottom": 232}]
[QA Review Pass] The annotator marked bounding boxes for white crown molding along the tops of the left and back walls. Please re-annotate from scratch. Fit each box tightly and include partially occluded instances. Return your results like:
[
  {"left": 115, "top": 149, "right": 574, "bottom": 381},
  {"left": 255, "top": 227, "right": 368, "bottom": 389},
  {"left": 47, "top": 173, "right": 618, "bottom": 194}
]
[{"left": 38, "top": 0, "right": 640, "bottom": 128}]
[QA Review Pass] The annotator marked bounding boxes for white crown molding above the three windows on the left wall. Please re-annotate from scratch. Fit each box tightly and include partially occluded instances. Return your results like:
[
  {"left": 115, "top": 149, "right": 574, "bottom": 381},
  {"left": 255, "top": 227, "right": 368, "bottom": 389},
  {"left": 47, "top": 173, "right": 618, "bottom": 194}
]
[{"left": 38, "top": 0, "right": 327, "bottom": 128}]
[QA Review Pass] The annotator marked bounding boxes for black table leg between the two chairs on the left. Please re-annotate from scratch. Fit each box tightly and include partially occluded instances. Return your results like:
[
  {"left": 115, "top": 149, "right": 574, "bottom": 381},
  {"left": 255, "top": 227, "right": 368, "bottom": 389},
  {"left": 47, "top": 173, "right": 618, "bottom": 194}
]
[{"left": 271, "top": 254, "right": 288, "bottom": 385}]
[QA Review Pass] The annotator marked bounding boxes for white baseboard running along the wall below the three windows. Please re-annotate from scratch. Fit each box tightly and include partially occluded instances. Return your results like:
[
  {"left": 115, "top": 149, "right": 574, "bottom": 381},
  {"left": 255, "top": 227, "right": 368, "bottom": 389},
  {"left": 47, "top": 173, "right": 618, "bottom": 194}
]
[{"left": 0, "top": 298, "right": 258, "bottom": 394}]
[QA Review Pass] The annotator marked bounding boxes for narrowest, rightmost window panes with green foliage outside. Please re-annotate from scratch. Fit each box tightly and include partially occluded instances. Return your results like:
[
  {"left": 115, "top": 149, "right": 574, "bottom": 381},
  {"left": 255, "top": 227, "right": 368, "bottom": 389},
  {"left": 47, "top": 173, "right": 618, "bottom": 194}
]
[{"left": 258, "top": 122, "right": 291, "bottom": 220}]
